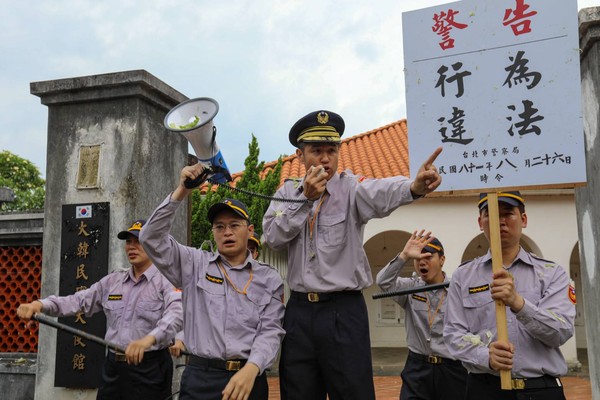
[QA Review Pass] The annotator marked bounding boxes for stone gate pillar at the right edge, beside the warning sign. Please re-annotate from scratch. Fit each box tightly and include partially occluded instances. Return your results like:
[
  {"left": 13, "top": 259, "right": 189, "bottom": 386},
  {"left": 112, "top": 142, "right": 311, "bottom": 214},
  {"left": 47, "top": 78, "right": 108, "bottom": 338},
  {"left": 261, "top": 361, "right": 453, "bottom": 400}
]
[{"left": 575, "top": 7, "right": 600, "bottom": 400}]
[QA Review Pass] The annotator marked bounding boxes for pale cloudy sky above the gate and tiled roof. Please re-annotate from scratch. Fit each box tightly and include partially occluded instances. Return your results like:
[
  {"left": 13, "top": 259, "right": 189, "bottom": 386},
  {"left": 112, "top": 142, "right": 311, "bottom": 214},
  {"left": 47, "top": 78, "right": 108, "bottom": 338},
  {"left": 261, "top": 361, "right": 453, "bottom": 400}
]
[{"left": 0, "top": 0, "right": 600, "bottom": 176}]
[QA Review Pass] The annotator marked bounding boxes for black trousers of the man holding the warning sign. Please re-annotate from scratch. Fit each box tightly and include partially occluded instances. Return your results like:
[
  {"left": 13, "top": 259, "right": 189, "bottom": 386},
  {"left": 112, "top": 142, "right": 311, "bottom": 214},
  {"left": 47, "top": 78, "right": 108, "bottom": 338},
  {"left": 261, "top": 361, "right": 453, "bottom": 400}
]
[{"left": 465, "top": 374, "right": 565, "bottom": 400}]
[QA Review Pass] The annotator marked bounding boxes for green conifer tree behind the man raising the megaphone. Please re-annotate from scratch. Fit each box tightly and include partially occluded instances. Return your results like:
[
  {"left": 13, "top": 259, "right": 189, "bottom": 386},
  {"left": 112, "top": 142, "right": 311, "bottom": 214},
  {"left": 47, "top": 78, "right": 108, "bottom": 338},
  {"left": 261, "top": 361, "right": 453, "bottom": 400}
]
[{"left": 191, "top": 135, "right": 283, "bottom": 247}]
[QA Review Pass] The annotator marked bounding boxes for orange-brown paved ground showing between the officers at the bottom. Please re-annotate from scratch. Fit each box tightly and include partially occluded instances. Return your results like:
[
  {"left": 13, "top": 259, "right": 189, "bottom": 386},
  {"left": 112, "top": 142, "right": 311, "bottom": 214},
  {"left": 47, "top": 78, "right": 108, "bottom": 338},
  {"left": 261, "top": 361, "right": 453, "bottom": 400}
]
[{"left": 268, "top": 349, "right": 592, "bottom": 400}]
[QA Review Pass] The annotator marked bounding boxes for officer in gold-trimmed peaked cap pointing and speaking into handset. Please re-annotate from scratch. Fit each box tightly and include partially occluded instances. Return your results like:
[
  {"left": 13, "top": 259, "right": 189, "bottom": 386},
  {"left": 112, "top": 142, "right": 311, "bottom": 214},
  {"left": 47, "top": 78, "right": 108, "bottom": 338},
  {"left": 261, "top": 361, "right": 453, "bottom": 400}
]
[{"left": 263, "top": 110, "right": 441, "bottom": 400}]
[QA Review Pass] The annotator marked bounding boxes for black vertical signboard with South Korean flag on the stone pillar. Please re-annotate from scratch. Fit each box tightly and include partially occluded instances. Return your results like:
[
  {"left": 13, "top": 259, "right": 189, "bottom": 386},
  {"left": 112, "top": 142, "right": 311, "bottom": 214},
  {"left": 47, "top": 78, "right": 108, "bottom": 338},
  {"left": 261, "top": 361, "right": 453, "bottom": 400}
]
[{"left": 54, "top": 203, "right": 110, "bottom": 388}]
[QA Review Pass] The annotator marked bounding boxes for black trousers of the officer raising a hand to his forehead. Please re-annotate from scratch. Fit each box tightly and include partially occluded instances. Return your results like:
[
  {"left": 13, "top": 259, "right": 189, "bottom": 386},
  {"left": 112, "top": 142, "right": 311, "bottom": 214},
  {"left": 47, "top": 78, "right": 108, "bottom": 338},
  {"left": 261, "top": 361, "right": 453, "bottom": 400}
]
[{"left": 400, "top": 351, "right": 467, "bottom": 400}]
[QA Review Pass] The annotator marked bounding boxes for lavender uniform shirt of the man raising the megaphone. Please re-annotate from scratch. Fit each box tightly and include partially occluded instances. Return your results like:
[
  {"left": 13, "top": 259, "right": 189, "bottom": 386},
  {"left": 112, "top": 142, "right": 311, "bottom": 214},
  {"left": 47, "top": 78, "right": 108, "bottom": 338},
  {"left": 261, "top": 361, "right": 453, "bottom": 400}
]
[{"left": 140, "top": 195, "right": 284, "bottom": 373}]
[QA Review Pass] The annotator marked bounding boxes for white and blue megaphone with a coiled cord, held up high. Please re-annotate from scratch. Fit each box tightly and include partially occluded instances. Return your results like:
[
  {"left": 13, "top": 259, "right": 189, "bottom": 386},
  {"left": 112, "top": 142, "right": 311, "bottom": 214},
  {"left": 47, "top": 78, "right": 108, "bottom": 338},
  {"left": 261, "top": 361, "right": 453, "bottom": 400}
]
[{"left": 164, "top": 97, "right": 232, "bottom": 189}]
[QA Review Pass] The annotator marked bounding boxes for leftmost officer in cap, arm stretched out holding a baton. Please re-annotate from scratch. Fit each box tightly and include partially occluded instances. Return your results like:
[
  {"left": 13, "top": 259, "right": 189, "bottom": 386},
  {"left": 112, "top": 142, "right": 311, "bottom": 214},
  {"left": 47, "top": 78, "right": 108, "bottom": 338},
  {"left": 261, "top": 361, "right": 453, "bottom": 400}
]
[{"left": 17, "top": 219, "right": 183, "bottom": 400}]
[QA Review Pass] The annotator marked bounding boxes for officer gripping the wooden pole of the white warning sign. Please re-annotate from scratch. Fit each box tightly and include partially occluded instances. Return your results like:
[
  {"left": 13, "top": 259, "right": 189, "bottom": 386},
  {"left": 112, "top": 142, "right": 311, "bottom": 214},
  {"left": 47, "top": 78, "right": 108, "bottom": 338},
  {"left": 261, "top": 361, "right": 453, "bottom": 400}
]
[{"left": 444, "top": 191, "right": 575, "bottom": 400}]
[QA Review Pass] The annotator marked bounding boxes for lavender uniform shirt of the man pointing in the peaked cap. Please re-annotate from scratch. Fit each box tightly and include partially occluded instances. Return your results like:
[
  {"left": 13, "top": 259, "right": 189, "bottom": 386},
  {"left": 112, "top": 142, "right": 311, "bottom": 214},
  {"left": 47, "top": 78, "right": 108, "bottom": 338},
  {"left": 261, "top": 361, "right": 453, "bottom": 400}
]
[{"left": 263, "top": 172, "right": 413, "bottom": 293}]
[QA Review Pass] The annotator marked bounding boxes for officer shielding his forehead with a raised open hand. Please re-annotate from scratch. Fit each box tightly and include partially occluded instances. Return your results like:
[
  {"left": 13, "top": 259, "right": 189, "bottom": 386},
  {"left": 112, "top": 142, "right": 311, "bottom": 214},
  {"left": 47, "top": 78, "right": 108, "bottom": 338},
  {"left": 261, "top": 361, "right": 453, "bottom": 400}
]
[{"left": 376, "top": 230, "right": 467, "bottom": 400}]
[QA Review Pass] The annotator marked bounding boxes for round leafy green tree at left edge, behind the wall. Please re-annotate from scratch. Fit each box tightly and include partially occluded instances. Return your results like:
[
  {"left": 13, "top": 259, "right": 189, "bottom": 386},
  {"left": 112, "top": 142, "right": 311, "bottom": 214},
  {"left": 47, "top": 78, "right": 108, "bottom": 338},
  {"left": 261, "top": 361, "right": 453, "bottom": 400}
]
[{"left": 0, "top": 150, "right": 46, "bottom": 211}]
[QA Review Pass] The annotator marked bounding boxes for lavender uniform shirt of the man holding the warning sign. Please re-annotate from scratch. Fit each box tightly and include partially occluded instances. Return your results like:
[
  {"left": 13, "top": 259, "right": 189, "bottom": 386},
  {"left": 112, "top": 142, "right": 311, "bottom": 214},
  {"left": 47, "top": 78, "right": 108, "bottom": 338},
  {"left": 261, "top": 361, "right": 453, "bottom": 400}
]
[{"left": 444, "top": 248, "right": 575, "bottom": 378}]
